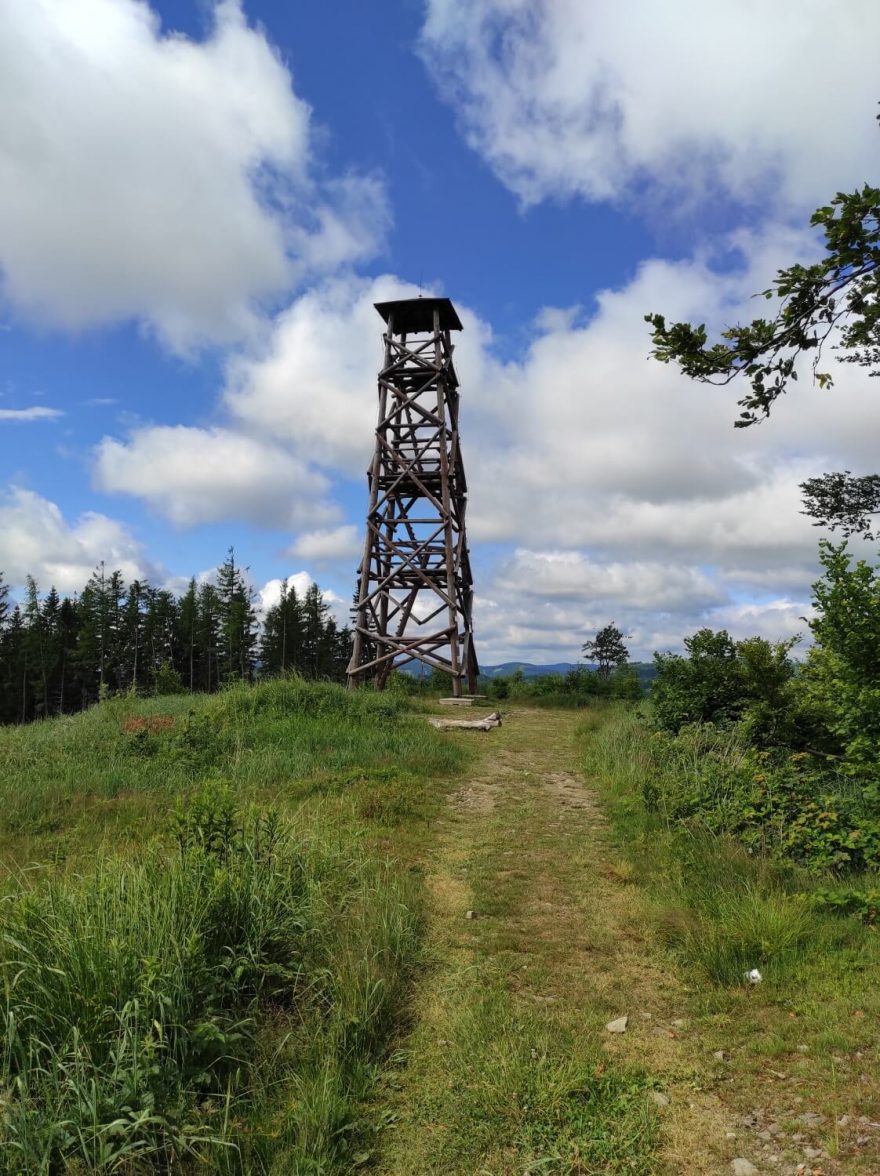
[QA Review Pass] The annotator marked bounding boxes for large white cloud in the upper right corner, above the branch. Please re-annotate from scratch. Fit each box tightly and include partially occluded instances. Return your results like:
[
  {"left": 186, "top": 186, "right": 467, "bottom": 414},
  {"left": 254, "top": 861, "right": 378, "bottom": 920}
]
[{"left": 421, "top": 0, "right": 880, "bottom": 207}]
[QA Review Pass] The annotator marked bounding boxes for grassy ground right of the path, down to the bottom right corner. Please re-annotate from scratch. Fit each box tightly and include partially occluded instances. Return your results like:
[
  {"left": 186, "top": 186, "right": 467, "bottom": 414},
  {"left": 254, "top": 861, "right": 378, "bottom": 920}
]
[{"left": 581, "top": 710, "right": 880, "bottom": 1172}]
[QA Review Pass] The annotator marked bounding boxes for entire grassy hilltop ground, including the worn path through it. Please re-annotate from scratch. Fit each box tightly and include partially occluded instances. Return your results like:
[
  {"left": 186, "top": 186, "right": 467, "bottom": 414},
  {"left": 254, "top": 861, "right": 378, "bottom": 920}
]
[{"left": 6, "top": 679, "right": 880, "bottom": 1176}]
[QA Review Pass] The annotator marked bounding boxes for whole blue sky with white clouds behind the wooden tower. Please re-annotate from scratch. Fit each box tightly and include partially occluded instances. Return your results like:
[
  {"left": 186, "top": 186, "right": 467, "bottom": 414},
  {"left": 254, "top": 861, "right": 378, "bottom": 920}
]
[{"left": 0, "top": 0, "right": 880, "bottom": 662}]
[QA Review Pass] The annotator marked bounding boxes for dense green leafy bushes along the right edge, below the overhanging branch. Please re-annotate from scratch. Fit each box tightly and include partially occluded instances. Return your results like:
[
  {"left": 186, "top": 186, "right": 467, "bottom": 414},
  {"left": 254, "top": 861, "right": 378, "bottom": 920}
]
[{"left": 630, "top": 543, "right": 880, "bottom": 874}]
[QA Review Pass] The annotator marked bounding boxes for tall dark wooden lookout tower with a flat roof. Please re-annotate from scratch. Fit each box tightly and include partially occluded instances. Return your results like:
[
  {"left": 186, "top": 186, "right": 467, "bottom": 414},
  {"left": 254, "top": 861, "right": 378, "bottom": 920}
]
[{"left": 348, "top": 298, "right": 479, "bottom": 697}]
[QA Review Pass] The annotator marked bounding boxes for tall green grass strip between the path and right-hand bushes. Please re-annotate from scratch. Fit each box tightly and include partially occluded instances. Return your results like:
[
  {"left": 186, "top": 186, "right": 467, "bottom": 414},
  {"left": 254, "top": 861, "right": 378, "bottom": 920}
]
[{"left": 582, "top": 709, "right": 861, "bottom": 985}]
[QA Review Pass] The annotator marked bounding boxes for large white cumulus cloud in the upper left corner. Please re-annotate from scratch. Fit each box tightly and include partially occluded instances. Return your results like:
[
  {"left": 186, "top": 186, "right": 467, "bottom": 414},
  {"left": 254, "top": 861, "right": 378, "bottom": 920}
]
[{"left": 0, "top": 0, "right": 388, "bottom": 350}]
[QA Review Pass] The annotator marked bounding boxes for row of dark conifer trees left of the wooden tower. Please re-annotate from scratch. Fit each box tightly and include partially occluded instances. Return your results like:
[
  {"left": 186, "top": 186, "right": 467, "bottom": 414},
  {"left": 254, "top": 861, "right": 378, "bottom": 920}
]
[{"left": 0, "top": 548, "right": 351, "bottom": 723}]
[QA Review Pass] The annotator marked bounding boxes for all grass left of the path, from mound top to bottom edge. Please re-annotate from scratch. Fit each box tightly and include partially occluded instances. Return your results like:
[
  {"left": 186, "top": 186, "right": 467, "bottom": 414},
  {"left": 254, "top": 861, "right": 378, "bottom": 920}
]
[{"left": 0, "top": 680, "right": 467, "bottom": 1176}]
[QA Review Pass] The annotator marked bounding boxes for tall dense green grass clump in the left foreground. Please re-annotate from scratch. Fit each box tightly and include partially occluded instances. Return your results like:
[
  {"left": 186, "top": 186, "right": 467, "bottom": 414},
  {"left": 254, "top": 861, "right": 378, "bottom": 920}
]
[{"left": 0, "top": 791, "right": 416, "bottom": 1172}]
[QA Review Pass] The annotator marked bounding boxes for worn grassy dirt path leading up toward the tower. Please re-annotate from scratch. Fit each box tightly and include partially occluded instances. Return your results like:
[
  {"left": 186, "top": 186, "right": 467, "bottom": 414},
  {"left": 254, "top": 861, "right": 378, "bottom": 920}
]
[{"left": 376, "top": 709, "right": 739, "bottom": 1176}]
